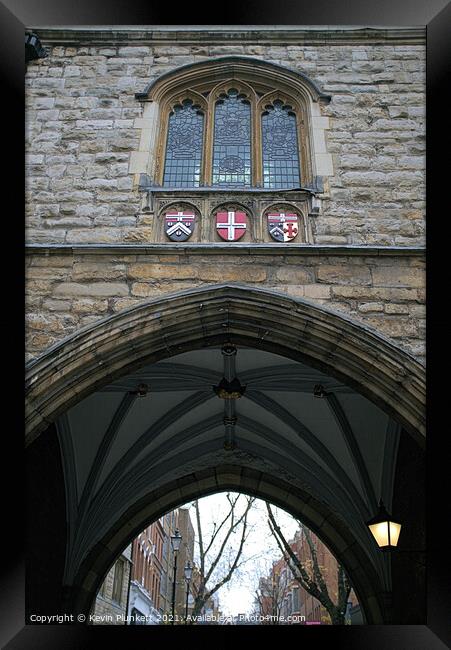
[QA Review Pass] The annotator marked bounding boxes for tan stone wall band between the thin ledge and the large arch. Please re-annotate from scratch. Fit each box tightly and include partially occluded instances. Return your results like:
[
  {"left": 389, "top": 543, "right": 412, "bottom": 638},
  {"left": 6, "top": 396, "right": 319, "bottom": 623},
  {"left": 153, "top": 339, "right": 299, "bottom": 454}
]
[{"left": 26, "top": 246, "right": 425, "bottom": 359}]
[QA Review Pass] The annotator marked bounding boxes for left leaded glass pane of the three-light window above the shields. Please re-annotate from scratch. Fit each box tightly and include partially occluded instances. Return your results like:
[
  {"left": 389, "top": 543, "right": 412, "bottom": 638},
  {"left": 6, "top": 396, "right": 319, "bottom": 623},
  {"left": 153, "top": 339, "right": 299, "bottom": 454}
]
[{"left": 163, "top": 99, "right": 204, "bottom": 187}]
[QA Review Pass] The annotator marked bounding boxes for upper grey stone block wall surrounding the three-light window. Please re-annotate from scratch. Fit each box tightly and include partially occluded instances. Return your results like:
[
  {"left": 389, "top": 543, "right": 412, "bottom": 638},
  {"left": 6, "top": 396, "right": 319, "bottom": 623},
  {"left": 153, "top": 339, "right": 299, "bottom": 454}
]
[{"left": 26, "top": 30, "right": 425, "bottom": 245}]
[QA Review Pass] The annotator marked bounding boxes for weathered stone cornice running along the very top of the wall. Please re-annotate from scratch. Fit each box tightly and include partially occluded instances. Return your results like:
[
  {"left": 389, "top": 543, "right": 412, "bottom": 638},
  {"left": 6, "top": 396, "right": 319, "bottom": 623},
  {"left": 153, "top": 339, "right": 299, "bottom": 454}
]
[{"left": 28, "top": 25, "right": 426, "bottom": 46}]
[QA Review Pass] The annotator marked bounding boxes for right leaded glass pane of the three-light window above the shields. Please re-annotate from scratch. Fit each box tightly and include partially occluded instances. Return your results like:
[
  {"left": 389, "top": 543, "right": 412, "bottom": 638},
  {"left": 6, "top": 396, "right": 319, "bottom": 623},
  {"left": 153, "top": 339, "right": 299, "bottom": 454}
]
[{"left": 262, "top": 100, "right": 301, "bottom": 189}]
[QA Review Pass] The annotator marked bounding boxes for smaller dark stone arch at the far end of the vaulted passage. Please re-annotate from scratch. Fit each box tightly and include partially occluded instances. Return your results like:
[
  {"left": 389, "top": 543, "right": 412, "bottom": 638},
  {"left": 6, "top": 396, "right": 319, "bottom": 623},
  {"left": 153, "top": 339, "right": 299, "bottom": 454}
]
[{"left": 72, "top": 464, "right": 389, "bottom": 624}]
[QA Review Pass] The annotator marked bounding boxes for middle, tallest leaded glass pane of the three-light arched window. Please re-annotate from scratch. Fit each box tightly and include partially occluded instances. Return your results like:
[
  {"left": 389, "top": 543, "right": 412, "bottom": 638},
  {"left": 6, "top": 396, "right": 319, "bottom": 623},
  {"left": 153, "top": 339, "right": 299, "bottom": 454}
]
[{"left": 212, "top": 89, "right": 252, "bottom": 187}]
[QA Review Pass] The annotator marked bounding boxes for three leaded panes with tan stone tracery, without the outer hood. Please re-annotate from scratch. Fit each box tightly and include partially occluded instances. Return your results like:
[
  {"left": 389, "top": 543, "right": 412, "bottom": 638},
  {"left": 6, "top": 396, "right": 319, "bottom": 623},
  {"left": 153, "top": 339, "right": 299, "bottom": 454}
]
[{"left": 157, "top": 80, "right": 306, "bottom": 189}]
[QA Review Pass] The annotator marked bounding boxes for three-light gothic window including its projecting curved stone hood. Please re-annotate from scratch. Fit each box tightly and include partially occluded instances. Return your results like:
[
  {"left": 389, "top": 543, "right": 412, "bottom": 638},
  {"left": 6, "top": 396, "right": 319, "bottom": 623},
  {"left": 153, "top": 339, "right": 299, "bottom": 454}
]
[{"left": 143, "top": 57, "right": 330, "bottom": 189}]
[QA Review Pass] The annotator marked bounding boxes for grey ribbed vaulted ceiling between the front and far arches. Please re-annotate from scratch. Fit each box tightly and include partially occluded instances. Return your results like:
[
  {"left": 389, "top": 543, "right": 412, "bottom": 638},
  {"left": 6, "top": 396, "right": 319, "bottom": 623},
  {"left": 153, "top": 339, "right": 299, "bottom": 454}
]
[{"left": 57, "top": 347, "right": 400, "bottom": 582}]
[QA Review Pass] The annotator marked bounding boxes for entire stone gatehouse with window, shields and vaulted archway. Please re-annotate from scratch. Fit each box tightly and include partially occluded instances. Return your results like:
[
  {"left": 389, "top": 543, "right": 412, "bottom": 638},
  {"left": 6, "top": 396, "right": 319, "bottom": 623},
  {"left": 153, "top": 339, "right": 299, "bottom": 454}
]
[{"left": 26, "top": 27, "right": 426, "bottom": 624}]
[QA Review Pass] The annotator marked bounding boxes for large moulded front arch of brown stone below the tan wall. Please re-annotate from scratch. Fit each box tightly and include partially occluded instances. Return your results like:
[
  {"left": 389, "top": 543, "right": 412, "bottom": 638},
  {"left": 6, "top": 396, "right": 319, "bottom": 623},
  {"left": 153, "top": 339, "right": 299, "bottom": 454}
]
[{"left": 26, "top": 283, "right": 425, "bottom": 446}]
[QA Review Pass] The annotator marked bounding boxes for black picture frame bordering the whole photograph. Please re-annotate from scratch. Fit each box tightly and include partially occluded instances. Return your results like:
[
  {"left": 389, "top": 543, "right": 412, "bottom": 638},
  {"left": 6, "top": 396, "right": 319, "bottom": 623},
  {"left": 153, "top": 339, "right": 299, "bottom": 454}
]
[{"left": 4, "top": 0, "right": 451, "bottom": 650}]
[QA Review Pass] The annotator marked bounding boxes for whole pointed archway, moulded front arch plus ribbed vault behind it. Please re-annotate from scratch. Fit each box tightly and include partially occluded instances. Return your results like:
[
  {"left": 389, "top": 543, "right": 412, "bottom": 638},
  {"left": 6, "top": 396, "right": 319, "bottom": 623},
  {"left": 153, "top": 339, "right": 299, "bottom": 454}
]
[{"left": 24, "top": 285, "right": 424, "bottom": 623}]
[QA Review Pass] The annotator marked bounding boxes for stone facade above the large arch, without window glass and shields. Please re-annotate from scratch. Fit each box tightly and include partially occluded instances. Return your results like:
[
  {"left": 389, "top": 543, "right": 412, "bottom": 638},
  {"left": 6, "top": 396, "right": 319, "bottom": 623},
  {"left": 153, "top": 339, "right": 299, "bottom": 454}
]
[{"left": 26, "top": 28, "right": 425, "bottom": 360}]
